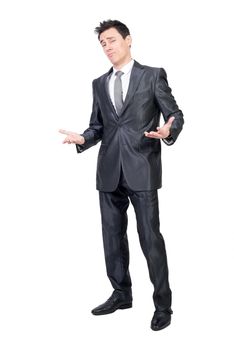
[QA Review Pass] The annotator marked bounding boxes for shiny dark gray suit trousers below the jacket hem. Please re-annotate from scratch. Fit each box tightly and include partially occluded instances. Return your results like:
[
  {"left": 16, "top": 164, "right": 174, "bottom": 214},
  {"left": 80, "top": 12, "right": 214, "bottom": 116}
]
[{"left": 99, "top": 170, "right": 171, "bottom": 311}]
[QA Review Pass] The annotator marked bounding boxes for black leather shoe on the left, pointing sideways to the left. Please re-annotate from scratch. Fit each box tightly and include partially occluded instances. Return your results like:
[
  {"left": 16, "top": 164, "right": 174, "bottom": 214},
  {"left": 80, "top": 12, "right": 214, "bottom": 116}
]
[{"left": 91, "top": 291, "right": 132, "bottom": 316}]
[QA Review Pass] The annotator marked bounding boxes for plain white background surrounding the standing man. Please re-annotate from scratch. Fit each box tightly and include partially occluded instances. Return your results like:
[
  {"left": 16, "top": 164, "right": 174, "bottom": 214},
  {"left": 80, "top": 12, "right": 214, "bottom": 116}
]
[{"left": 0, "top": 0, "right": 234, "bottom": 350}]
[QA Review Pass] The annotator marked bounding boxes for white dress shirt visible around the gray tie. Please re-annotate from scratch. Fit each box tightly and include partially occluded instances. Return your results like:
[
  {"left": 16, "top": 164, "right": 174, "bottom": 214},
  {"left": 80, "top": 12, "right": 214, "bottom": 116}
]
[{"left": 109, "top": 59, "right": 134, "bottom": 110}]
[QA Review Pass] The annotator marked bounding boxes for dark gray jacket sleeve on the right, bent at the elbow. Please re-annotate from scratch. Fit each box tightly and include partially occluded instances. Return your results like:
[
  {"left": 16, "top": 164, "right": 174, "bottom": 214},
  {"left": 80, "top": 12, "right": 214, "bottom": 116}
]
[{"left": 155, "top": 68, "right": 184, "bottom": 146}]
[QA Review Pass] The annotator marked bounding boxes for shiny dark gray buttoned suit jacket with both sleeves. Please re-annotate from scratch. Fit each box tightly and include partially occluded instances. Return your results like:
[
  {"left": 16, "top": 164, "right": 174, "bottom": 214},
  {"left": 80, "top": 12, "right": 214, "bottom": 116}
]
[{"left": 76, "top": 61, "right": 184, "bottom": 192}]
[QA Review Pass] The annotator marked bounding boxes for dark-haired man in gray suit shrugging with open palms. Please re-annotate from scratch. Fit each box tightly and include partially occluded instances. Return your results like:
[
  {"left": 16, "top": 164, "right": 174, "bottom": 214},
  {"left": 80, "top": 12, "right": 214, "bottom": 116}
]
[{"left": 60, "top": 20, "right": 184, "bottom": 331}]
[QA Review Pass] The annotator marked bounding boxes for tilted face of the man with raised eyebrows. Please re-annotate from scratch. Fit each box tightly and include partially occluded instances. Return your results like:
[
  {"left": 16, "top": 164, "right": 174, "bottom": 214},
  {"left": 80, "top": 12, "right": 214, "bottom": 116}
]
[{"left": 99, "top": 28, "right": 131, "bottom": 67}]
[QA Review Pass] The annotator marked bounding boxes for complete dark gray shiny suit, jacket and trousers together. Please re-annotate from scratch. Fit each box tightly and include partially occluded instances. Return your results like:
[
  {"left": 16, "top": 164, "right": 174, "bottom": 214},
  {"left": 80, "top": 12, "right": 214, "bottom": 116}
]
[{"left": 76, "top": 61, "right": 184, "bottom": 310}]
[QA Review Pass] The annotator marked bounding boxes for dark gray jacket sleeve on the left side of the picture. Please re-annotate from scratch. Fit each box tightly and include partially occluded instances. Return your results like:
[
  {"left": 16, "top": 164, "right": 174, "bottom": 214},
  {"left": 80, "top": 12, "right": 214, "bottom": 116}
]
[{"left": 76, "top": 81, "right": 103, "bottom": 153}]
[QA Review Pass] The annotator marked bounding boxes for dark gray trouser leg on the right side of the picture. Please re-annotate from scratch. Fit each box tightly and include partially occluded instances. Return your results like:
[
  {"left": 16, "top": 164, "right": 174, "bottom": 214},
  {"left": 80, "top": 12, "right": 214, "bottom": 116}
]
[{"left": 130, "top": 190, "right": 171, "bottom": 311}]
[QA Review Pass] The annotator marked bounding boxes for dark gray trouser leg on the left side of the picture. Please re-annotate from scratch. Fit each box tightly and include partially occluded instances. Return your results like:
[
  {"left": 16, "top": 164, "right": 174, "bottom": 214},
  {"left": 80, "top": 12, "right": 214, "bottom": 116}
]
[{"left": 99, "top": 187, "right": 132, "bottom": 294}]
